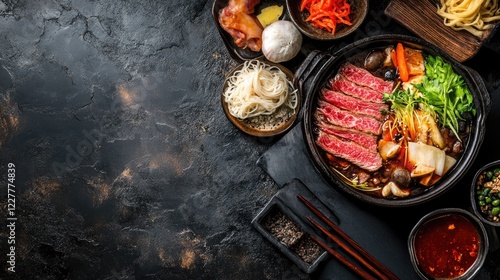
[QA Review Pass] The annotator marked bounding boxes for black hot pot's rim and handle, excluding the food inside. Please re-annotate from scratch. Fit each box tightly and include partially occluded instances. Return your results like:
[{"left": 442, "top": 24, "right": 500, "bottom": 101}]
[{"left": 294, "top": 34, "right": 491, "bottom": 207}]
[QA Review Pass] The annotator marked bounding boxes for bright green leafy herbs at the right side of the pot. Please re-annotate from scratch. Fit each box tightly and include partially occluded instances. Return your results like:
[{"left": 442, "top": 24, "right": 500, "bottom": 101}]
[{"left": 414, "top": 56, "right": 476, "bottom": 139}]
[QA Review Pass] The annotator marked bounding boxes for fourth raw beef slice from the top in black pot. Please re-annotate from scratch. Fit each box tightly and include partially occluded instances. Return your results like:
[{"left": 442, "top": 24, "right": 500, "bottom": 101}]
[{"left": 318, "top": 100, "right": 382, "bottom": 135}]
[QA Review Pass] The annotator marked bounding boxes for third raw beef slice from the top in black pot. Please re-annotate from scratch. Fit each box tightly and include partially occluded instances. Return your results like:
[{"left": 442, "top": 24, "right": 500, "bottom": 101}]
[{"left": 321, "top": 89, "right": 389, "bottom": 120}]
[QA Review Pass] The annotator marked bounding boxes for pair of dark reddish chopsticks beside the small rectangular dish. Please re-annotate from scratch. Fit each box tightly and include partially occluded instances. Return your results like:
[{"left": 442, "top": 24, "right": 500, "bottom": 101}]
[{"left": 297, "top": 194, "right": 399, "bottom": 280}]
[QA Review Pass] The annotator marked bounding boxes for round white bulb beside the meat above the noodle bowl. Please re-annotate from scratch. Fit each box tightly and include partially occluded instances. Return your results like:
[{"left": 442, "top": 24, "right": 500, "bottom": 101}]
[{"left": 262, "top": 20, "right": 302, "bottom": 63}]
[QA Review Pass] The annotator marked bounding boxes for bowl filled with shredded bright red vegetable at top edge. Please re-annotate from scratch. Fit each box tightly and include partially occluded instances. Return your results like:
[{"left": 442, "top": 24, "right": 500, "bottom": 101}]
[{"left": 286, "top": 0, "right": 368, "bottom": 41}]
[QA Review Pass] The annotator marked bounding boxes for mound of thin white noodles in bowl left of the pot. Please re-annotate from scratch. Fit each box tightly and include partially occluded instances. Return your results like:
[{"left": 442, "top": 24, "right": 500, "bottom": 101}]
[{"left": 224, "top": 60, "right": 297, "bottom": 119}]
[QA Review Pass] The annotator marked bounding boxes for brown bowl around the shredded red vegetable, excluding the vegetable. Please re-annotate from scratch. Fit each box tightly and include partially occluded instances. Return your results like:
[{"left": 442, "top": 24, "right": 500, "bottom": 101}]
[{"left": 286, "top": 0, "right": 368, "bottom": 41}]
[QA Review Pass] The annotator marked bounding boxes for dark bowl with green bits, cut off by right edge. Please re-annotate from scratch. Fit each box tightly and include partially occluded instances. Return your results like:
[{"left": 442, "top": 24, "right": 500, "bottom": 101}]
[{"left": 470, "top": 160, "right": 500, "bottom": 227}]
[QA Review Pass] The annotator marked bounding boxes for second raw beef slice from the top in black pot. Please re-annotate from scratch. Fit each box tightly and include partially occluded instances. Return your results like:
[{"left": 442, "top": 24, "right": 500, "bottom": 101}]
[{"left": 330, "top": 75, "right": 384, "bottom": 103}]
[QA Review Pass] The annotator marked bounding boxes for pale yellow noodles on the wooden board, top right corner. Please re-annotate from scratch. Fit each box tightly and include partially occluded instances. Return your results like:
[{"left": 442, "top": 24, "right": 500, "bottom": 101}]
[{"left": 437, "top": 0, "right": 500, "bottom": 37}]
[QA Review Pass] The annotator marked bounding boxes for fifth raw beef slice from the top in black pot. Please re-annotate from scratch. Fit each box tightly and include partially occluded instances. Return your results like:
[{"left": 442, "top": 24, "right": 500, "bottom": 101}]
[{"left": 316, "top": 118, "right": 377, "bottom": 153}]
